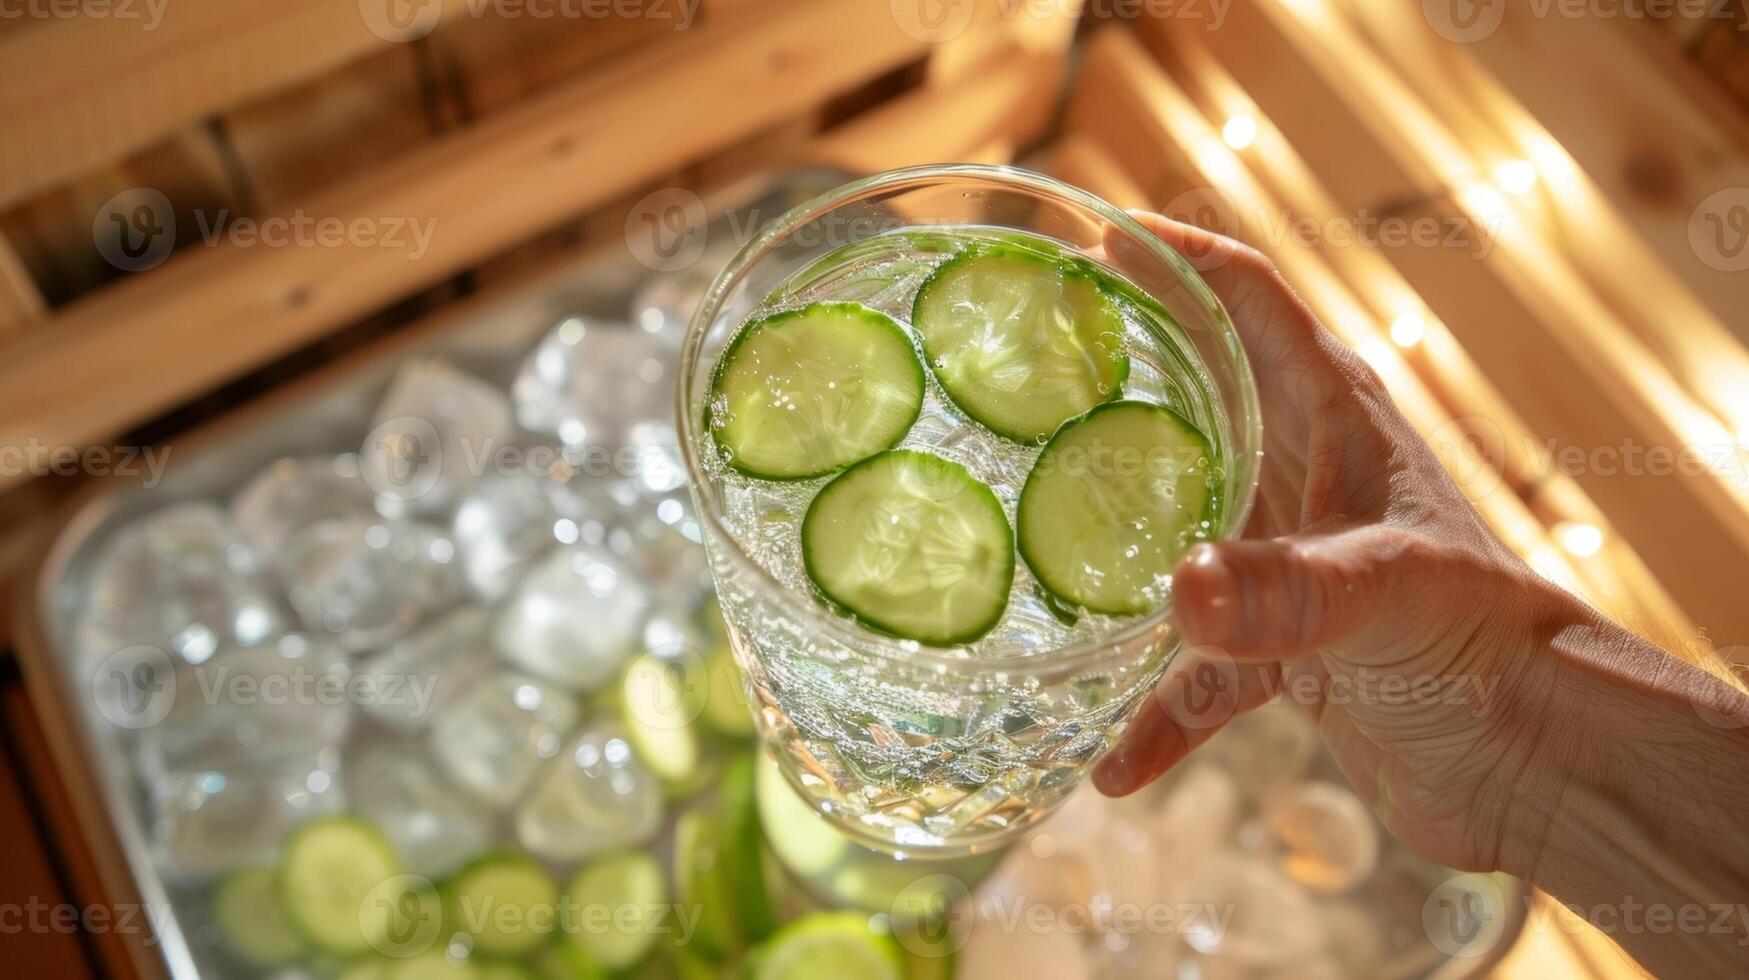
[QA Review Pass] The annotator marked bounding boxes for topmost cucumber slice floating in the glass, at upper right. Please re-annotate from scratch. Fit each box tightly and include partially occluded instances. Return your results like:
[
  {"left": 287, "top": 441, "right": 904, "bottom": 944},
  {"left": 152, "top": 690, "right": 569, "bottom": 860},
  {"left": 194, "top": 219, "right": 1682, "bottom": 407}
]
[{"left": 911, "top": 245, "right": 1130, "bottom": 443}]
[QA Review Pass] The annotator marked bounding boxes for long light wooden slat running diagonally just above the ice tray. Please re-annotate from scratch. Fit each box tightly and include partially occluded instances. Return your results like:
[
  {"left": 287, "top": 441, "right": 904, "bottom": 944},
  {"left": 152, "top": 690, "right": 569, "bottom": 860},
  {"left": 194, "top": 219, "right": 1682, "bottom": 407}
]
[{"left": 0, "top": 0, "right": 944, "bottom": 483}]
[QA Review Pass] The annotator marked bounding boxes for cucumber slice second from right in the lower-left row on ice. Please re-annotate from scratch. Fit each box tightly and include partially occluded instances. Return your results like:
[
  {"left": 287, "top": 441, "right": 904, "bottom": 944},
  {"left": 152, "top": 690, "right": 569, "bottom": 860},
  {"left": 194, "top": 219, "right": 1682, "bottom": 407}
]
[{"left": 444, "top": 851, "right": 558, "bottom": 956}]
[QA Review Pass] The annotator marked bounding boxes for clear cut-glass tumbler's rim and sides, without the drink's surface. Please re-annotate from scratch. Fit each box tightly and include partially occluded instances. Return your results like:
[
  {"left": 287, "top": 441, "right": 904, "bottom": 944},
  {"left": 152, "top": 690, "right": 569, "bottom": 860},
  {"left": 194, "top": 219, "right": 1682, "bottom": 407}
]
[{"left": 679, "top": 165, "right": 1261, "bottom": 858}]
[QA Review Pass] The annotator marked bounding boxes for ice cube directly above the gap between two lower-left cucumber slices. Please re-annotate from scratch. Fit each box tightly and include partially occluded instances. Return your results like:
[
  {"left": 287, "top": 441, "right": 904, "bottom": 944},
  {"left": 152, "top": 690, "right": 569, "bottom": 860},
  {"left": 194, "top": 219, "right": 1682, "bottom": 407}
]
[{"left": 345, "top": 739, "right": 493, "bottom": 879}]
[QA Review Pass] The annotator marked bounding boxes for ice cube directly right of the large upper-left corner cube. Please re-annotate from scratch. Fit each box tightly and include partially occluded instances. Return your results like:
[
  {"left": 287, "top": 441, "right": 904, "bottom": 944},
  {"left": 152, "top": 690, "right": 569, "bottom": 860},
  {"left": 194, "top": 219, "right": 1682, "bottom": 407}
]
[{"left": 282, "top": 520, "right": 462, "bottom": 651}]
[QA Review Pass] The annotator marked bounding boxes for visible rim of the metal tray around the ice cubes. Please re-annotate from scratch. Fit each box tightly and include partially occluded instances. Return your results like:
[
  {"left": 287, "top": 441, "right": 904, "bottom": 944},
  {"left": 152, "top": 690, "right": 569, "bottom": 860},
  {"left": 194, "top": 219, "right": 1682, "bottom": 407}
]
[{"left": 16, "top": 170, "right": 1525, "bottom": 980}]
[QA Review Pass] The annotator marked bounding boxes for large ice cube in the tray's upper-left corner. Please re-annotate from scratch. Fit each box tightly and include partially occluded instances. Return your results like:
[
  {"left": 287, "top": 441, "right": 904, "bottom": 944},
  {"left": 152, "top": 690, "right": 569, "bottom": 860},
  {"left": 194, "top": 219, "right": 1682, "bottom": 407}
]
[{"left": 77, "top": 502, "right": 289, "bottom": 663}]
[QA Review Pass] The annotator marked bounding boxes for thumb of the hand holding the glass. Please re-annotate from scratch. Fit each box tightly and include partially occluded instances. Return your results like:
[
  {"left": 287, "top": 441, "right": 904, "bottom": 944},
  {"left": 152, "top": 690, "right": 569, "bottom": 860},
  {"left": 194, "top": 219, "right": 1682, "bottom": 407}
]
[{"left": 1172, "top": 525, "right": 1403, "bottom": 660}]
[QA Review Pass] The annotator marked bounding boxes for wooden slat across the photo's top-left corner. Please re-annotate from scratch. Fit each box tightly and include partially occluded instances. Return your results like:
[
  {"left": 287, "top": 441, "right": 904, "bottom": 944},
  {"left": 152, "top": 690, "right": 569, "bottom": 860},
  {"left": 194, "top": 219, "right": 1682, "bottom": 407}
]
[{"left": 0, "top": 0, "right": 463, "bottom": 205}]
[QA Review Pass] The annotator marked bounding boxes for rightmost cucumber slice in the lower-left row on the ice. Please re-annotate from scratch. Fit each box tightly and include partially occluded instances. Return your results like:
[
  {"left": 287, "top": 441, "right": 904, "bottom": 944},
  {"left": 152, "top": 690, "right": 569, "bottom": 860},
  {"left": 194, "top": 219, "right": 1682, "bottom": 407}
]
[{"left": 570, "top": 851, "right": 668, "bottom": 970}]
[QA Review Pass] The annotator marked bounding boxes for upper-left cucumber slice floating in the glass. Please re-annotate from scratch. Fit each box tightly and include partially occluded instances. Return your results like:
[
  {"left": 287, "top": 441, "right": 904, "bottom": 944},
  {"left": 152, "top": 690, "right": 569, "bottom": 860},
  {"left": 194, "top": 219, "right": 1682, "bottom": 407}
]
[{"left": 710, "top": 303, "right": 923, "bottom": 480}]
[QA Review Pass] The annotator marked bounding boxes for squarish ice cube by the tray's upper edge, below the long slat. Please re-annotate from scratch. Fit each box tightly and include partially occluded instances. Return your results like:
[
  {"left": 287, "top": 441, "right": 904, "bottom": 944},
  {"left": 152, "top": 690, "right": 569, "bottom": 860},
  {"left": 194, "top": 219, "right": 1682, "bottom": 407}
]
[{"left": 359, "top": 361, "right": 514, "bottom": 516}]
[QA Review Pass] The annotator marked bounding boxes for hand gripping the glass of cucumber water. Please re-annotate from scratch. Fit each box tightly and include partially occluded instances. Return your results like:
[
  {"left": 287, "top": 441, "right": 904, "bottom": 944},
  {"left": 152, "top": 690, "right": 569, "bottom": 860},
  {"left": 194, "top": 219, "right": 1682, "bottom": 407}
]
[{"left": 1095, "top": 215, "right": 1600, "bottom": 870}]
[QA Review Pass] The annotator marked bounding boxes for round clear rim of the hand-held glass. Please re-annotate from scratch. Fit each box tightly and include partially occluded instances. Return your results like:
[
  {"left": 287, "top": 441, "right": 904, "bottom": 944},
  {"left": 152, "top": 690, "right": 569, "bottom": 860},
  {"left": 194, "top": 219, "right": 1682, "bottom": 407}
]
[{"left": 675, "top": 163, "right": 1263, "bottom": 674}]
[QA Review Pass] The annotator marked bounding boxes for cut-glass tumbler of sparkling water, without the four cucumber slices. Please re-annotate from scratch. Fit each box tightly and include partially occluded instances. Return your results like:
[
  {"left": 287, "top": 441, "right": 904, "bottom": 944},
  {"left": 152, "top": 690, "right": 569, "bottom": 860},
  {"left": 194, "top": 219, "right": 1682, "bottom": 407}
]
[{"left": 680, "top": 166, "right": 1259, "bottom": 856}]
